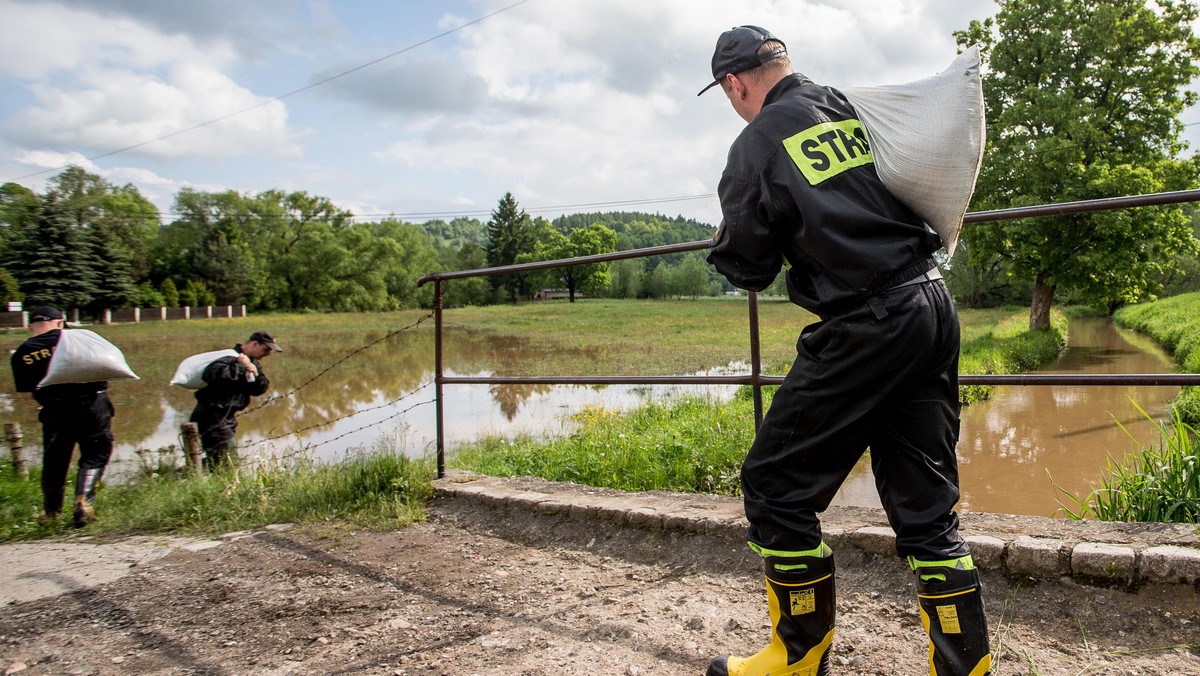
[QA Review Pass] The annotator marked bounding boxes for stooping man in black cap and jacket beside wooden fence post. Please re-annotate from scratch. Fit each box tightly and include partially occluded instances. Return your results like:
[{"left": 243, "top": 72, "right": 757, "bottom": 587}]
[{"left": 191, "top": 331, "right": 283, "bottom": 469}]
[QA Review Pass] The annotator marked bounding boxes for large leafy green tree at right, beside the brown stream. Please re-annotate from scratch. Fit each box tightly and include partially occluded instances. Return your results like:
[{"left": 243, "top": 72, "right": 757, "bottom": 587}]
[{"left": 955, "top": 0, "right": 1200, "bottom": 329}]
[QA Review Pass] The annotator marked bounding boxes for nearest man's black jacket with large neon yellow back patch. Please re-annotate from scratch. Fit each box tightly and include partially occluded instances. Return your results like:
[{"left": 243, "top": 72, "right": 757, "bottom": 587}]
[{"left": 708, "top": 73, "right": 941, "bottom": 317}]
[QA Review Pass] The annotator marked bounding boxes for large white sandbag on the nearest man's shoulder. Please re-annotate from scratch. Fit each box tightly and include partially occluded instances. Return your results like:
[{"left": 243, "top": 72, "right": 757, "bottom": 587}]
[{"left": 841, "top": 46, "right": 984, "bottom": 255}]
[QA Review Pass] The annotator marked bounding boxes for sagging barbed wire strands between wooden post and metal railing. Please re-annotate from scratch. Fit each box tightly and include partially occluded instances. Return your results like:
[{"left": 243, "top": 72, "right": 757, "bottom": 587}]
[{"left": 178, "top": 312, "right": 436, "bottom": 460}]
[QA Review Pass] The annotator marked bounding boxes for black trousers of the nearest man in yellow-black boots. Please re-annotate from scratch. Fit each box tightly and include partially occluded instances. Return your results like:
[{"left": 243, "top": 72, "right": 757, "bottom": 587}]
[{"left": 742, "top": 280, "right": 968, "bottom": 561}]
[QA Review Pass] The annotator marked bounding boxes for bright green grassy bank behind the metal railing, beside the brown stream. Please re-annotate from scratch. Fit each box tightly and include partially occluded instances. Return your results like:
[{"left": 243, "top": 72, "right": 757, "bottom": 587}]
[{"left": 450, "top": 310, "right": 1066, "bottom": 495}]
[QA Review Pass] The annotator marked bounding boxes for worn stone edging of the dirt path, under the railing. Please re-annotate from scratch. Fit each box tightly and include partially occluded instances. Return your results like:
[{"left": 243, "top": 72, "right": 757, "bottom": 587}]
[{"left": 434, "top": 472, "right": 1200, "bottom": 587}]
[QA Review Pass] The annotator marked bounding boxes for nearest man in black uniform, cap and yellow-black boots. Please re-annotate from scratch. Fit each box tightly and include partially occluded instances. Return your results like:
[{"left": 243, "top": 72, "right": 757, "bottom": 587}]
[{"left": 701, "top": 26, "right": 991, "bottom": 676}]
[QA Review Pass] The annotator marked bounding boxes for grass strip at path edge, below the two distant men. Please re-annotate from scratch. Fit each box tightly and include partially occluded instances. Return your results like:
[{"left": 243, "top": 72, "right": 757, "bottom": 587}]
[{"left": 0, "top": 448, "right": 433, "bottom": 540}]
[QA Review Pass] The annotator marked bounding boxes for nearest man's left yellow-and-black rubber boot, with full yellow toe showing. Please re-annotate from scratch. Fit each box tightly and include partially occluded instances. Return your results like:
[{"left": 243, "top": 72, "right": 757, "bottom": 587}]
[{"left": 706, "top": 543, "right": 835, "bottom": 676}]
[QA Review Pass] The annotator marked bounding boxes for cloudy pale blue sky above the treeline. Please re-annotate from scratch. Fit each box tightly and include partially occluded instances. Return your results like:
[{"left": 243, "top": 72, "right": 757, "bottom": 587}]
[{"left": 0, "top": 0, "right": 1200, "bottom": 225}]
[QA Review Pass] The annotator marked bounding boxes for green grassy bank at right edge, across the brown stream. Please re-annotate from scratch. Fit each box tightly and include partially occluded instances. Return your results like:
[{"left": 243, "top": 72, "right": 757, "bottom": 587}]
[{"left": 1112, "top": 292, "right": 1200, "bottom": 426}]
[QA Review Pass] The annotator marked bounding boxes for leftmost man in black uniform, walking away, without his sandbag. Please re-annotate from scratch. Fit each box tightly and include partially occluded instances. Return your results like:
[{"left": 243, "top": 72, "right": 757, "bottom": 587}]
[{"left": 11, "top": 305, "right": 113, "bottom": 528}]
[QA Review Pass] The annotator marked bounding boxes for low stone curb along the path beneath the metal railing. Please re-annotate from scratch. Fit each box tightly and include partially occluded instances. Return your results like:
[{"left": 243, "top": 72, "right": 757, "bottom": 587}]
[{"left": 434, "top": 472, "right": 1200, "bottom": 586}]
